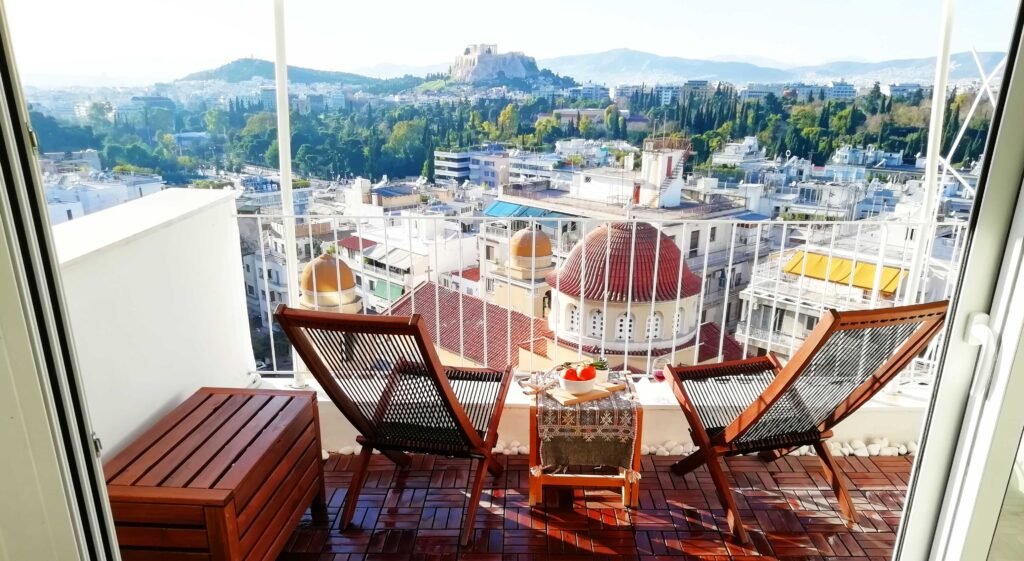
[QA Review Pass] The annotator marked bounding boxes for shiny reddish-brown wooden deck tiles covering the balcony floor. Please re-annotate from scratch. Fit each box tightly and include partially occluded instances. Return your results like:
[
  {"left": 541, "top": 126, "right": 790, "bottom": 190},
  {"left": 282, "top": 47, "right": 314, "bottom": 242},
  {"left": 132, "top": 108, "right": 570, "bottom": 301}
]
[{"left": 279, "top": 456, "right": 912, "bottom": 561}]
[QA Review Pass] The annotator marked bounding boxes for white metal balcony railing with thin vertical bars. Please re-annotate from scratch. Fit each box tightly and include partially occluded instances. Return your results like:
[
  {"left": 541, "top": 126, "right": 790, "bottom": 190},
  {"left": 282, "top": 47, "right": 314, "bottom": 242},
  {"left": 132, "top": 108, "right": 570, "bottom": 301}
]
[{"left": 238, "top": 215, "right": 967, "bottom": 377}]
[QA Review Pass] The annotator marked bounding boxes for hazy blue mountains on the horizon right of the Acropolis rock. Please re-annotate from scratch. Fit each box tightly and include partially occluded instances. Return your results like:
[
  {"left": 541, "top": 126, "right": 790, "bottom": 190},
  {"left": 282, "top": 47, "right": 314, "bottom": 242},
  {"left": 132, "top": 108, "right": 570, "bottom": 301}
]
[{"left": 539, "top": 49, "right": 1004, "bottom": 85}]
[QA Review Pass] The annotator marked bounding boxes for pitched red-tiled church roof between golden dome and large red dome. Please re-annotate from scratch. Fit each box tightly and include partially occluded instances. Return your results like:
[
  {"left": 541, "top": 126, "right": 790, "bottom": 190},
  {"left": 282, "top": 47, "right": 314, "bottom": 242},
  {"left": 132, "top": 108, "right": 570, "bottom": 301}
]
[{"left": 391, "top": 283, "right": 551, "bottom": 369}]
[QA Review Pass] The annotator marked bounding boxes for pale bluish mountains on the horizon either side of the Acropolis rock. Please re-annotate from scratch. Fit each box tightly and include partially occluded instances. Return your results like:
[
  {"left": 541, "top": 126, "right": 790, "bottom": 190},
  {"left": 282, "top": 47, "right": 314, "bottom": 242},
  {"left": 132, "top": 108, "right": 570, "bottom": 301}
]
[{"left": 181, "top": 49, "right": 1005, "bottom": 89}]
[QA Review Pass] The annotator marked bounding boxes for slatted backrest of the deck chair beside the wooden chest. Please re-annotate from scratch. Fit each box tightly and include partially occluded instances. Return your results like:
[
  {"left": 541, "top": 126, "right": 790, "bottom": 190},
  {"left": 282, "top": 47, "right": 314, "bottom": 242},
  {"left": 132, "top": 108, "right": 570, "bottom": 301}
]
[{"left": 274, "top": 305, "right": 483, "bottom": 452}]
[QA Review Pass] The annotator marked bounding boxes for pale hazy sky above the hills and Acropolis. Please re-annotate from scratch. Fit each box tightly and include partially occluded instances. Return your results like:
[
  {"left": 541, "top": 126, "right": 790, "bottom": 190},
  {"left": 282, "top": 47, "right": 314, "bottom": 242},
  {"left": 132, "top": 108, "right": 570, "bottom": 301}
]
[{"left": 4, "top": 0, "right": 1017, "bottom": 85}]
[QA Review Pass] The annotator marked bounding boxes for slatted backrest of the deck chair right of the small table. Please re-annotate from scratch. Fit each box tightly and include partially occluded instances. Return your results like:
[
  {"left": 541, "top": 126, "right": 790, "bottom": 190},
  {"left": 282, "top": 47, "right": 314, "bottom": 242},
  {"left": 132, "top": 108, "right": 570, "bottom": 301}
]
[{"left": 721, "top": 301, "right": 948, "bottom": 446}]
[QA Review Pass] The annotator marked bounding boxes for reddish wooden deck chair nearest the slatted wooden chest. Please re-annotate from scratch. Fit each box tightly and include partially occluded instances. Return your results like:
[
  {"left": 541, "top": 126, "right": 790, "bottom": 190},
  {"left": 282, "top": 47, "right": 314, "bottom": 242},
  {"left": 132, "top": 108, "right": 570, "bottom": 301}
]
[{"left": 274, "top": 305, "right": 512, "bottom": 545}]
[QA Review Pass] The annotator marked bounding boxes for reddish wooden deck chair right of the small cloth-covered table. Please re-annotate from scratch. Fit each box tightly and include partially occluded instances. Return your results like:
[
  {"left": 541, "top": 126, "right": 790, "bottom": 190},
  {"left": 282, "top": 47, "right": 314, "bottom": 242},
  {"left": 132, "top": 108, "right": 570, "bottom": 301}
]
[{"left": 669, "top": 302, "right": 948, "bottom": 543}]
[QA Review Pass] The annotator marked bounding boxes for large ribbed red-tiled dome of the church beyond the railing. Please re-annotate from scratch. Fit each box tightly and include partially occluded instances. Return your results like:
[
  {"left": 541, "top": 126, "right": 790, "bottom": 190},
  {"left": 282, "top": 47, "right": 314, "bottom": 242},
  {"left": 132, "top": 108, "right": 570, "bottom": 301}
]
[{"left": 547, "top": 222, "right": 700, "bottom": 302}]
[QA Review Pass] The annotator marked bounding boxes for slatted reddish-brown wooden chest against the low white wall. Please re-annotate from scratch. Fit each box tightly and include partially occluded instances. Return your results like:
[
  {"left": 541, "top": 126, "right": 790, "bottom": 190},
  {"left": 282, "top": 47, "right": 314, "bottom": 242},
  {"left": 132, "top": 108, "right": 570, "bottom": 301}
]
[{"left": 103, "top": 388, "right": 327, "bottom": 561}]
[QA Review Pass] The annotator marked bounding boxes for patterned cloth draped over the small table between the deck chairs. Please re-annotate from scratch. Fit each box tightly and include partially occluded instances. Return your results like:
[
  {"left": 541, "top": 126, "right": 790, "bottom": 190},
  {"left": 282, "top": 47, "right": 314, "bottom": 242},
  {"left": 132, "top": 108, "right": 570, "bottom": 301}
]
[{"left": 537, "top": 375, "right": 639, "bottom": 471}]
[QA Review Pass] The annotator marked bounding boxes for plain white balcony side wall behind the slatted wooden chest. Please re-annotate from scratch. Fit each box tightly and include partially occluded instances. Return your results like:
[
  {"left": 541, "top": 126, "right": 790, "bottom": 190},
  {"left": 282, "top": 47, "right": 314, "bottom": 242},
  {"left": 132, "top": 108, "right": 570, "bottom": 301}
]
[{"left": 53, "top": 189, "right": 255, "bottom": 458}]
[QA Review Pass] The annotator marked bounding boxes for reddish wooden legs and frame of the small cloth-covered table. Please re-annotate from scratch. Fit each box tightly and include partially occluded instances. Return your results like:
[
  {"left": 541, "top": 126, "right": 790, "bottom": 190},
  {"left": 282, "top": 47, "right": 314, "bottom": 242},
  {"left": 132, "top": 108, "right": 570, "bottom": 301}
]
[{"left": 529, "top": 382, "right": 643, "bottom": 509}]
